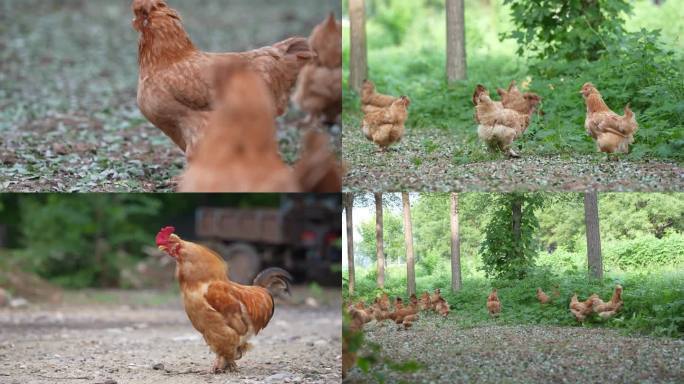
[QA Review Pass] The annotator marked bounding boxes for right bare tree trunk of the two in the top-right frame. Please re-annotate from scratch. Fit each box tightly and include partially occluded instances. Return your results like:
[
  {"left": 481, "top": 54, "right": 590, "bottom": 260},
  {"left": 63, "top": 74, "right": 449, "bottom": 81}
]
[{"left": 446, "top": 0, "right": 467, "bottom": 83}]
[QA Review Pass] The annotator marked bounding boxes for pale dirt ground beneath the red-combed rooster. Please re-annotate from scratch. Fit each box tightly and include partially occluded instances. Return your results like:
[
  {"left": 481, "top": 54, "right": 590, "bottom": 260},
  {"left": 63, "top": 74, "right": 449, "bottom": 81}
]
[{"left": 0, "top": 291, "right": 342, "bottom": 384}]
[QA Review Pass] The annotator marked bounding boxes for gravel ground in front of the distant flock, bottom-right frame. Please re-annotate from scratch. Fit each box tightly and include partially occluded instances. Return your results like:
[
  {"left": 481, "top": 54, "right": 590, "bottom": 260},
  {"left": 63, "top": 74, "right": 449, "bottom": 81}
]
[{"left": 348, "top": 316, "right": 684, "bottom": 383}]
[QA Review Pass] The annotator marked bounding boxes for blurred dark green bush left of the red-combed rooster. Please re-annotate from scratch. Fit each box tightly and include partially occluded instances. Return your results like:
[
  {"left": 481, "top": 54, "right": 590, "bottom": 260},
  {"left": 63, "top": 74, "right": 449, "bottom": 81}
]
[{"left": 21, "top": 194, "right": 159, "bottom": 288}]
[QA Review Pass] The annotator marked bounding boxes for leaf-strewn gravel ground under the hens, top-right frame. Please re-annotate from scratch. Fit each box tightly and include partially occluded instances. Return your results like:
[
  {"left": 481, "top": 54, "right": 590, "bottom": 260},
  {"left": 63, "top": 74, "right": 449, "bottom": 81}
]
[{"left": 342, "top": 125, "right": 684, "bottom": 192}]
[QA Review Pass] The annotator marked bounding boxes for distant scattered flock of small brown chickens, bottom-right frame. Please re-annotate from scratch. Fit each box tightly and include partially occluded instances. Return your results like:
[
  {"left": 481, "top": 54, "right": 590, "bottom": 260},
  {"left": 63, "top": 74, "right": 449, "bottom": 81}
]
[{"left": 342, "top": 284, "right": 623, "bottom": 377}]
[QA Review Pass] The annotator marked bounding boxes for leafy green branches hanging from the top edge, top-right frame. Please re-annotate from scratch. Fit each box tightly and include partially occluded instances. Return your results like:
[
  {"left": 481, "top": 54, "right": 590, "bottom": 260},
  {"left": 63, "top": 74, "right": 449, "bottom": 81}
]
[{"left": 503, "top": 0, "right": 632, "bottom": 61}]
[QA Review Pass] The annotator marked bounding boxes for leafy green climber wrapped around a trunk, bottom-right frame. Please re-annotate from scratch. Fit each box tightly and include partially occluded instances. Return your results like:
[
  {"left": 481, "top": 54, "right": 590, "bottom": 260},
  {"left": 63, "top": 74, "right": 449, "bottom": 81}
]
[{"left": 480, "top": 193, "right": 544, "bottom": 279}]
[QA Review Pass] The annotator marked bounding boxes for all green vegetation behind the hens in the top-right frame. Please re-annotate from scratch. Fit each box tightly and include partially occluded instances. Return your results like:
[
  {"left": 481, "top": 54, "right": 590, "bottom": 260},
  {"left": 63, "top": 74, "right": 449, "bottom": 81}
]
[{"left": 343, "top": 0, "right": 684, "bottom": 161}]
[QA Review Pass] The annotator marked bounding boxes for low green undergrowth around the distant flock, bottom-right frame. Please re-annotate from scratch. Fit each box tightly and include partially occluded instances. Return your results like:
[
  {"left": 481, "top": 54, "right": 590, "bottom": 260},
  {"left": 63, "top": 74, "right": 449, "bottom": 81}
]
[{"left": 343, "top": 259, "right": 684, "bottom": 337}]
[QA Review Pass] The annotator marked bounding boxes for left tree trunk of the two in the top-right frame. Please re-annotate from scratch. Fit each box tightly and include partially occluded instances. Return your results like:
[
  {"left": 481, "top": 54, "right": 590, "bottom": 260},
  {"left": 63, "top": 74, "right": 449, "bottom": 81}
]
[{"left": 349, "top": 0, "right": 368, "bottom": 92}]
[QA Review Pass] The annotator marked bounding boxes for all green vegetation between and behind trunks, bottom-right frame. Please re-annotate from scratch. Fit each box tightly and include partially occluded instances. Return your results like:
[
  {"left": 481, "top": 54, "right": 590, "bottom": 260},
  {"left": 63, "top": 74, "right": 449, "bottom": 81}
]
[{"left": 343, "top": 193, "right": 684, "bottom": 337}]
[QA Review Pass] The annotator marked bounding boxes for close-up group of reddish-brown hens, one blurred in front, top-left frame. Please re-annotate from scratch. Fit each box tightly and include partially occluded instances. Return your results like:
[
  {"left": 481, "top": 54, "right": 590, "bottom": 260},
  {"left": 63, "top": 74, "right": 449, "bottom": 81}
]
[{"left": 132, "top": 0, "right": 342, "bottom": 192}]
